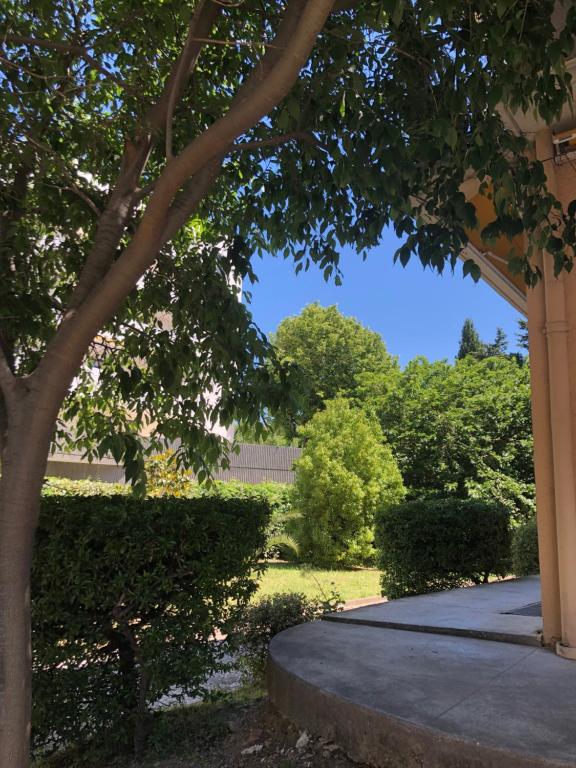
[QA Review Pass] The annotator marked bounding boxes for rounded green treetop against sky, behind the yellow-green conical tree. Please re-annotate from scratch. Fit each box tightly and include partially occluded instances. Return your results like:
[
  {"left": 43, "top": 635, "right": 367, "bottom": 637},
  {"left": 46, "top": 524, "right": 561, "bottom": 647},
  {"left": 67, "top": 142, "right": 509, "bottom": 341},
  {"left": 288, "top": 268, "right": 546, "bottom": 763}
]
[{"left": 272, "top": 304, "right": 398, "bottom": 437}]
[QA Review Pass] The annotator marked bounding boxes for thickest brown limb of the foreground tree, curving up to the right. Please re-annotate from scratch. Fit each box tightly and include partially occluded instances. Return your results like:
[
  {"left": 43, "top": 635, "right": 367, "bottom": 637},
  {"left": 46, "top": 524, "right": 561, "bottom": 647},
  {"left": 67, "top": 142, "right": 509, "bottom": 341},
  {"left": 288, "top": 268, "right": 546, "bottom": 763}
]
[{"left": 38, "top": 0, "right": 333, "bottom": 398}]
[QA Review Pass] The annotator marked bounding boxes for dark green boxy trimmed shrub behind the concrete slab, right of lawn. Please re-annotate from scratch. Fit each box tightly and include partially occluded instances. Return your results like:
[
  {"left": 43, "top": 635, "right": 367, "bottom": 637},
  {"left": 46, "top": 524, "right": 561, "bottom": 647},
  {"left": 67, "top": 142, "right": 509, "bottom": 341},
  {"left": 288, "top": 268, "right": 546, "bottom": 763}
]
[{"left": 376, "top": 499, "right": 511, "bottom": 598}]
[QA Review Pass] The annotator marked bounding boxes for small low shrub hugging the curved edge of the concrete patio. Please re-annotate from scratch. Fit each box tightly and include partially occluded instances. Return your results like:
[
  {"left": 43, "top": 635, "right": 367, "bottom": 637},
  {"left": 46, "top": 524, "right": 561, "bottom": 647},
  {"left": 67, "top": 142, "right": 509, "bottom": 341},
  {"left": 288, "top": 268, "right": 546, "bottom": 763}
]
[{"left": 232, "top": 592, "right": 343, "bottom": 682}]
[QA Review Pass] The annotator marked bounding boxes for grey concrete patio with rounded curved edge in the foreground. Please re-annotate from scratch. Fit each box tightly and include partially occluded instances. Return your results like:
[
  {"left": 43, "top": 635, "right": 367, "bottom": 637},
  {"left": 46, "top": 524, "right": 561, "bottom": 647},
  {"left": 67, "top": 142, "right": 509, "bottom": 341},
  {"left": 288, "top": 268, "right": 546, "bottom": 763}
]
[{"left": 269, "top": 581, "right": 576, "bottom": 768}]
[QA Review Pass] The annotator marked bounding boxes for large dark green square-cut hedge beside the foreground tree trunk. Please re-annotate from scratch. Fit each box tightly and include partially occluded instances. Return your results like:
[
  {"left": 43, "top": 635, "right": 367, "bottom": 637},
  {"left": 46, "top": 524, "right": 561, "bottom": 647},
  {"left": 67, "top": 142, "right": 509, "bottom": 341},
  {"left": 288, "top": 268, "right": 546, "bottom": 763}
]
[{"left": 32, "top": 495, "right": 270, "bottom": 751}]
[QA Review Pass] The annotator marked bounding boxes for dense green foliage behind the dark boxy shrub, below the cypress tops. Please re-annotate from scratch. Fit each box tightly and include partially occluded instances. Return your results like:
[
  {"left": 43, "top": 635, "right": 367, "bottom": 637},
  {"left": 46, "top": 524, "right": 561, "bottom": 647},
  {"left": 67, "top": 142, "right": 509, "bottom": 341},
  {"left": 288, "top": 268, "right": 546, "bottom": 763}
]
[{"left": 376, "top": 357, "right": 534, "bottom": 497}]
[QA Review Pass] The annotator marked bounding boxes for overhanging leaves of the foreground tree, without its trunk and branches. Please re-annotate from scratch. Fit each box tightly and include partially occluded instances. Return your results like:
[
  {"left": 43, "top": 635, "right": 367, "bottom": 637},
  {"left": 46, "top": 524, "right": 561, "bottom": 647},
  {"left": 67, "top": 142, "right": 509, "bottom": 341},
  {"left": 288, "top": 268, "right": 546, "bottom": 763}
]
[{"left": 0, "top": 0, "right": 576, "bottom": 479}]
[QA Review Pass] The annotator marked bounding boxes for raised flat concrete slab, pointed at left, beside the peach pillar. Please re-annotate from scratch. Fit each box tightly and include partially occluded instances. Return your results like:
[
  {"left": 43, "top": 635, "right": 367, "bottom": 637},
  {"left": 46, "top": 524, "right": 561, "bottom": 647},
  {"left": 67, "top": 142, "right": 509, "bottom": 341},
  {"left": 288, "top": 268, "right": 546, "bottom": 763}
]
[{"left": 326, "top": 576, "right": 542, "bottom": 645}]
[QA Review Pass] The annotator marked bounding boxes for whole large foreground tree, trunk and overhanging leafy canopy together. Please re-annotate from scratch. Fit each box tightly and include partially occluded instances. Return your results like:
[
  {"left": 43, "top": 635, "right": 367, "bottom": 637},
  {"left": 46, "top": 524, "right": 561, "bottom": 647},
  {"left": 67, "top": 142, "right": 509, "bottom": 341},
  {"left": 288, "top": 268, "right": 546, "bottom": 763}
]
[{"left": 0, "top": 0, "right": 576, "bottom": 768}]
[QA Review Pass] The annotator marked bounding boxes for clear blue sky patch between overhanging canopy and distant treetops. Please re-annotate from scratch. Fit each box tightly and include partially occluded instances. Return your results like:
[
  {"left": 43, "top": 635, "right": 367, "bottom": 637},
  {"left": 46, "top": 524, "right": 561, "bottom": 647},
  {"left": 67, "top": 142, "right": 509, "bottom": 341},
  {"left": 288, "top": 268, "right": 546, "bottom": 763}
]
[{"left": 245, "top": 224, "right": 521, "bottom": 365}]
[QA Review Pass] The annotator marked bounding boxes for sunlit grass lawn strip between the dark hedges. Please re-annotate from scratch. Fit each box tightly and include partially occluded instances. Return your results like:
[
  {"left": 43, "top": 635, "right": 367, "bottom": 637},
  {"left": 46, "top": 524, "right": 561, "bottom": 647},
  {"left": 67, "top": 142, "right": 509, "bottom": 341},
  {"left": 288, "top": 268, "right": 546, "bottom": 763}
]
[{"left": 257, "top": 563, "right": 380, "bottom": 600}]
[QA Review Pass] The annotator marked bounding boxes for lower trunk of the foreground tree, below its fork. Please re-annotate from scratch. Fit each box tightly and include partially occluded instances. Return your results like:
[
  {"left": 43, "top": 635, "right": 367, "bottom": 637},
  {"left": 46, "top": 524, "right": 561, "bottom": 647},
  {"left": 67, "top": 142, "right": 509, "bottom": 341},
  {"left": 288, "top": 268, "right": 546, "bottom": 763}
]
[{"left": 0, "top": 392, "right": 55, "bottom": 768}]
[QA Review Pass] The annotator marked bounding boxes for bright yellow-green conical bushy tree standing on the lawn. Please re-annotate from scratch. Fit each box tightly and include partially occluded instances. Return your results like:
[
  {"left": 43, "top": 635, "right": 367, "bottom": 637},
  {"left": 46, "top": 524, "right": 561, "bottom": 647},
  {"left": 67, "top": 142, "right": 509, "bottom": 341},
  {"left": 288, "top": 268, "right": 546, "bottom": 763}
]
[{"left": 295, "top": 398, "right": 404, "bottom": 567}]
